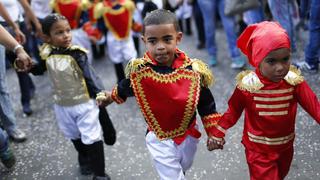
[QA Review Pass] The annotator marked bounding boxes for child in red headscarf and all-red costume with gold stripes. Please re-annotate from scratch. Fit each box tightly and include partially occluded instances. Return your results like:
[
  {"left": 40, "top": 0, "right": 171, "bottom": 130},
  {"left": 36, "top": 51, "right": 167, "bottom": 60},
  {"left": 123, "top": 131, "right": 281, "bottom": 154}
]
[{"left": 208, "top": 21, "right": 320, "bottom": 180}]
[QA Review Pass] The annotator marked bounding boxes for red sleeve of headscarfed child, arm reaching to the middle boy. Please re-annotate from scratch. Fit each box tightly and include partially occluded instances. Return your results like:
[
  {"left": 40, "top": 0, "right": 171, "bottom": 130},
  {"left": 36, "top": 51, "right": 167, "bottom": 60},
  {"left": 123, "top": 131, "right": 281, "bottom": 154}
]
[{"left": 213, "top": 88, "right": 246, "bottom": 138}]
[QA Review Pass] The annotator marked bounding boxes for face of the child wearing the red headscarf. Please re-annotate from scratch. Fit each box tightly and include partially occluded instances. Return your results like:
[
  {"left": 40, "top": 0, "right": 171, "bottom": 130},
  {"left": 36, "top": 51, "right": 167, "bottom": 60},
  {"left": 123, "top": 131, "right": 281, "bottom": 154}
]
[{"left": 259, "top": 48, "right": 291, "bottom": 82}]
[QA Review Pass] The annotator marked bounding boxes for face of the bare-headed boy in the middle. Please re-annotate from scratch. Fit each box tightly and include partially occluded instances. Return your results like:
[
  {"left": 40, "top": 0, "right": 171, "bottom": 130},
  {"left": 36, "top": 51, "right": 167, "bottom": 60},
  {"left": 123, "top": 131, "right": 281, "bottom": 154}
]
[{"left": 142, "top": 24, "right": 182, "bottom": 67}]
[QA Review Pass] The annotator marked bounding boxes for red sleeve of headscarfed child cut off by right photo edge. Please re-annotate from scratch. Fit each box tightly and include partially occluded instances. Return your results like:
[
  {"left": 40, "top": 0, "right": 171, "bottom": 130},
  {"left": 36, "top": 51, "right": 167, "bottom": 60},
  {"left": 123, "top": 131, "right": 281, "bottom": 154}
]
[{"left": 295, "top": 81, "right": 320, "bottom": 124}]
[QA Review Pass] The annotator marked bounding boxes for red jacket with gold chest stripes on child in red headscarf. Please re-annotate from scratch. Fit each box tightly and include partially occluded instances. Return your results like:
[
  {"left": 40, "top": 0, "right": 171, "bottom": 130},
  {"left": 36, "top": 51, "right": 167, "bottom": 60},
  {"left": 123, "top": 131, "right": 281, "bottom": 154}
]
[{"left": 213, "top": 67, "right": 320, "bottom": 152}]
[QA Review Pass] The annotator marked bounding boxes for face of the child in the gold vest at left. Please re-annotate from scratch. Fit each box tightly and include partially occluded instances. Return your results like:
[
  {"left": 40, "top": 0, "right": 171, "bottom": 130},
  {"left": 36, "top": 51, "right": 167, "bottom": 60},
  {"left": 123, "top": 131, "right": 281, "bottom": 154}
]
[{"left": 47, "top": 20, "right": 72, "bottom": 48}]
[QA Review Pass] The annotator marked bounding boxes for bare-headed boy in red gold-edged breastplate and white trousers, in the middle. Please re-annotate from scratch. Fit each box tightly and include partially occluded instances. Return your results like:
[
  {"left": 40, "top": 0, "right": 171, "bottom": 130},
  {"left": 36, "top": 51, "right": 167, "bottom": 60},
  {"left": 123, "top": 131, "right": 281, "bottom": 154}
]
[{"left": 97, "top": 9, "right": 220, "bottom": 180}]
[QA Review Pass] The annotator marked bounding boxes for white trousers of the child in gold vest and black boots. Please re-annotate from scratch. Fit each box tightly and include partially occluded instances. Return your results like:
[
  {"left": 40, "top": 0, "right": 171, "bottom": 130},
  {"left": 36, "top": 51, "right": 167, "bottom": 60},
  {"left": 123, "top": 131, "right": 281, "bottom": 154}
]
[{"left": 54, "top": 100, "right": 102, "bottom": 145}]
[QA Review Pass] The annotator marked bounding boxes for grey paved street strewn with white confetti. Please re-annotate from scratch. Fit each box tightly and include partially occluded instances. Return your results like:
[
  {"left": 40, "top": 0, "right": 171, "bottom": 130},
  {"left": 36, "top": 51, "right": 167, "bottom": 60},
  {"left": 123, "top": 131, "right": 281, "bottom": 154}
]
[{"left": 0, "top": 27, "right": 320, "bottom": 180}]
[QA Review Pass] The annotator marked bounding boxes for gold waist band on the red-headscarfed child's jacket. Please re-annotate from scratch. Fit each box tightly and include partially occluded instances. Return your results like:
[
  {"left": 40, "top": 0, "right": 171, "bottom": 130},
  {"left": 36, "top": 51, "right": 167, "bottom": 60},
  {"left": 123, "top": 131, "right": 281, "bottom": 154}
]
[{"left": 248, "top": 132, "right": 295, "bottom": 145}]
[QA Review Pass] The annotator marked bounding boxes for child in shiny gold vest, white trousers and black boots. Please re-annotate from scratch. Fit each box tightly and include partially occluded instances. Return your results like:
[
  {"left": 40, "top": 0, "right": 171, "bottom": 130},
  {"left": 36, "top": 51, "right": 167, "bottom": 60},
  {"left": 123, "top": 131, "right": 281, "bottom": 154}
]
[{"left": 31, "top": 14, "right": 110, "bottom": 179}]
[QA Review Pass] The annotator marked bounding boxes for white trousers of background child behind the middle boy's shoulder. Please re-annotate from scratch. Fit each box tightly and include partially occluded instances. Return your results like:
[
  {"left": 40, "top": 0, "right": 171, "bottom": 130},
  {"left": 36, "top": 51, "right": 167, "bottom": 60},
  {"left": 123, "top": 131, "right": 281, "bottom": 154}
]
[{"left": 107, "top": 32, "right": 137, "bottom": 63}]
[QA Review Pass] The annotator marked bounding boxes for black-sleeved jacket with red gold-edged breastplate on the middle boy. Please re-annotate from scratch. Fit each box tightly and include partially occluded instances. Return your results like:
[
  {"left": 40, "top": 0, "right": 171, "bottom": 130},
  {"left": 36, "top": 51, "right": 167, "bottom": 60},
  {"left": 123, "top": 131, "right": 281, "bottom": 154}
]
[{"left": 112, "top": 50, "right": 221, "bottom": 144}]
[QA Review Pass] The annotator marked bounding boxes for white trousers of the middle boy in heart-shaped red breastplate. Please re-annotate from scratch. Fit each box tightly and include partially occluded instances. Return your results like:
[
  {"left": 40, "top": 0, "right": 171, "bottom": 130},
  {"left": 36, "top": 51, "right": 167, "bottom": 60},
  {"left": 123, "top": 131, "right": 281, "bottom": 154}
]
[{"left": 146, "top": 131, "right": 199, "bottom": 180}]
